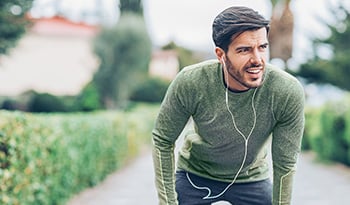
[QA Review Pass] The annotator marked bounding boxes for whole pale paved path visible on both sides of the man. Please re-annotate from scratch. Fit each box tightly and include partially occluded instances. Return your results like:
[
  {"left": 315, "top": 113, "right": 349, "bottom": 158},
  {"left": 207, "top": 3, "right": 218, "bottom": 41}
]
[{"left": 67, "top": 152, "right": 350, "bottom": 205}]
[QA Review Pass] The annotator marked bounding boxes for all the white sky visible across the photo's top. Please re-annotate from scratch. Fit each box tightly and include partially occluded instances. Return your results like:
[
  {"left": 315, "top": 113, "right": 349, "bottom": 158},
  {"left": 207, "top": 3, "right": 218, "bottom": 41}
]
[{"left": 33, "top": 0, "right": 344, "bottom": 67}]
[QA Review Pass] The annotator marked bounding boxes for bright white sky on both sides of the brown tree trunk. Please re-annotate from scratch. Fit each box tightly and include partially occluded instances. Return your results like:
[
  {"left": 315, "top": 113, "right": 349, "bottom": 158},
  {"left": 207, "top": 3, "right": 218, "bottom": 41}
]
[{"left": 144, "top": 0, "right": 345, "bottom": 67}]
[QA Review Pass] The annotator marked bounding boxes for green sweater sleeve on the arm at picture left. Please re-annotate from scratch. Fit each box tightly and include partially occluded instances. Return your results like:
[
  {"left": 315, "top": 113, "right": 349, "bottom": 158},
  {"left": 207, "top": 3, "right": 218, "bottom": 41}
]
[{"left": 152, "top": 71, "right": 191, "bottom": 205}]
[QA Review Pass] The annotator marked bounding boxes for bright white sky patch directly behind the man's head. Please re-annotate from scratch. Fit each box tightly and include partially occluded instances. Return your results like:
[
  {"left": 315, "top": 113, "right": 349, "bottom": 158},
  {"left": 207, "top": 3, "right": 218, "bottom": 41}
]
[{"left": 145, "top": 0, "right": 269, "bottom": 49}]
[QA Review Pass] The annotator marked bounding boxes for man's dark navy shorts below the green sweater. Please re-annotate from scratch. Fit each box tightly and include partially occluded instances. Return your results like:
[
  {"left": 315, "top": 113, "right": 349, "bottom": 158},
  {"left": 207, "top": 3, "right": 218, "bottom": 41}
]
[{"left": 176, "top": 171, "right": 272, "bottom": 205}]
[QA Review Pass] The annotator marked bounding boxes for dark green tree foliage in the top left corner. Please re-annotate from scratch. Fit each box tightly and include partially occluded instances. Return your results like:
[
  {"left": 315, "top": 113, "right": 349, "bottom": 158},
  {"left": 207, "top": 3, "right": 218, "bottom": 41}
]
[{"left": 0, "top": 0, "right": 33, "bottom": 55}]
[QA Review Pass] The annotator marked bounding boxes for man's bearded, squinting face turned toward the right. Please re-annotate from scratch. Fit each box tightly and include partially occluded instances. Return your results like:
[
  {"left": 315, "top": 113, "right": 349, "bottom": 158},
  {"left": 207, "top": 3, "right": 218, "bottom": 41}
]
[{"left": 223, "top": 28, "right": 268, "bottom": 91}]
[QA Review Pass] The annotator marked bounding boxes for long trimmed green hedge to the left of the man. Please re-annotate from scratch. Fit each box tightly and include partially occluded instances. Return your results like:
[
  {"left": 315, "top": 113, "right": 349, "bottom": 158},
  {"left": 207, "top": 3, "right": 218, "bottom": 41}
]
[{"left": 0, "top": 103, "right": 158, "bottom": 205}]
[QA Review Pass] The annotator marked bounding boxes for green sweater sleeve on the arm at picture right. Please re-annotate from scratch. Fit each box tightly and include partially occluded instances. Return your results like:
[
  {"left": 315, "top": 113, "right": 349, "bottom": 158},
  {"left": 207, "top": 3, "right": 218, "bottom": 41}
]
[{"left": 272, "top": 79, "right": 305, "bottom": 205}]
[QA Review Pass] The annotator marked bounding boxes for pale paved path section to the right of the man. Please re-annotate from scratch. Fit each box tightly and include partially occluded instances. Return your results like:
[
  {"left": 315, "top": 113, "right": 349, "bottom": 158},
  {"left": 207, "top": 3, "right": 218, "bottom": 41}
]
[{"left": 293, "top": 153, "right": 350, "bottom": 205}]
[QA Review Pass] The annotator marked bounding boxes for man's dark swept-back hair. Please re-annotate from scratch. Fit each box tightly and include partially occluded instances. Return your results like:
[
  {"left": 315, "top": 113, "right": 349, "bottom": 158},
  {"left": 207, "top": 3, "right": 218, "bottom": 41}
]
[{"left": 212, "top": 6, "right": 269, "bottom": 52}]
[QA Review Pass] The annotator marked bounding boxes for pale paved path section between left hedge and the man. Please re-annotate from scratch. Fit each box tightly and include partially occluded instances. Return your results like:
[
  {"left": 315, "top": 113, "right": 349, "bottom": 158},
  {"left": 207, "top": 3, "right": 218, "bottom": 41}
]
[{"left": 67, "top": 149, "right": 158, "bottom": 205}]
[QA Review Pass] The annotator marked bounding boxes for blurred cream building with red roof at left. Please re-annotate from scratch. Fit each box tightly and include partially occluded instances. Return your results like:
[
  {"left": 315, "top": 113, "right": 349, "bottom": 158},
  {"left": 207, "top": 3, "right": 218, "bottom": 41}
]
[{"left": 0, "top": 16, "right": 98, "bottom": 96}]
